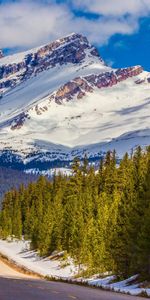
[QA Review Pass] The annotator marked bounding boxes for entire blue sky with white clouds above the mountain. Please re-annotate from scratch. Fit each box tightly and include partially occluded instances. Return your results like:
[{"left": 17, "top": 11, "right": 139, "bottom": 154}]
[{"left": 0, "top": 0, "right": 150, "bottom": 71}]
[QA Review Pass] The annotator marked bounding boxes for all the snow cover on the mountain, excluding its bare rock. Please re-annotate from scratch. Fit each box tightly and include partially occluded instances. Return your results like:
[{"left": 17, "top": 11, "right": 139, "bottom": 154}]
[{"left": 0, "top": 34, "right": 150, "bottom": 169}]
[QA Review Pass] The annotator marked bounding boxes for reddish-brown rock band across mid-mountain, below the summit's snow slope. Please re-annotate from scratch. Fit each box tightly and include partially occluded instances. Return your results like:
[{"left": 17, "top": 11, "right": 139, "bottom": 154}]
[{"left": 10, "top": 66, "right": 143, "bottom": 130}]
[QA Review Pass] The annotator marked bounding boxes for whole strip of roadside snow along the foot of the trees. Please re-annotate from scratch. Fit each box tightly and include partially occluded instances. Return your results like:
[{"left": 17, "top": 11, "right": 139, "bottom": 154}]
[{"left": 0, "top": 240, "right": 150, "bottom": 296}]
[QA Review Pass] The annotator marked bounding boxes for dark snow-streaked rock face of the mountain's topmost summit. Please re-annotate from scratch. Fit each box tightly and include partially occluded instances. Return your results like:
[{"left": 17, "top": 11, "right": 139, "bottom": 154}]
[{"left": 0, "top": 34, "right": 102, "bottom": 93}]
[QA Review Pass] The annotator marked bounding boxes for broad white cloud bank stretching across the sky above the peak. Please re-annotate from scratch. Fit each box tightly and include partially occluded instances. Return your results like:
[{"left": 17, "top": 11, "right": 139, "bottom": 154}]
[{"left": 0, "top": 0, "right": 150, "bottom": 48}]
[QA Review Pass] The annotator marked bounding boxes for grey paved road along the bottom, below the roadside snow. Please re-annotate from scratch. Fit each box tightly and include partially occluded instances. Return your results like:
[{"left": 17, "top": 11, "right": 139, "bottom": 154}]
[{"left": 0, "top": 277, "right": 143, "bottom": 300}]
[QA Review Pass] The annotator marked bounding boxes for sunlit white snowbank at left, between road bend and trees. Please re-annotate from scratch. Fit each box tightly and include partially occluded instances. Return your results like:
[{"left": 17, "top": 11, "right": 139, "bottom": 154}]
[{"left": 0, "top": 240, "right": 77, "bottom": 278}]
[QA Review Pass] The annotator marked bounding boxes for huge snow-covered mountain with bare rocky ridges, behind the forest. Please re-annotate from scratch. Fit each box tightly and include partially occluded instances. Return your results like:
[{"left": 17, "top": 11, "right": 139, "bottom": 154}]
[{"left": 0, "top": 34, "right": 150, "bottom": 168}]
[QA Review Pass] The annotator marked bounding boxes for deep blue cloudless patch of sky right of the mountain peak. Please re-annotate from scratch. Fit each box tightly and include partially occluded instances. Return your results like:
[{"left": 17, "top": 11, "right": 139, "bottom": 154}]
[{"left": 100, "top": 18, "right": 150, "bottom": 71}]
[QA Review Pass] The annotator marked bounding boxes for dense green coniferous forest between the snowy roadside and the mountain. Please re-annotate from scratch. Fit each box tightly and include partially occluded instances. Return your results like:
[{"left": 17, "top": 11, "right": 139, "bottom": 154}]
[{"left": 0, "top": 147, "right": 150, "bottom": 278}]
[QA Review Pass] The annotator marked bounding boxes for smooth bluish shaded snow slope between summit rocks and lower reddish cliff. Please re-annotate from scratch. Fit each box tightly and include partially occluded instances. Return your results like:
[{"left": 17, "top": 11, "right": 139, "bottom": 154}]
[{"left": 0, "top": 50, "right": 110, "bottom": 122}]
